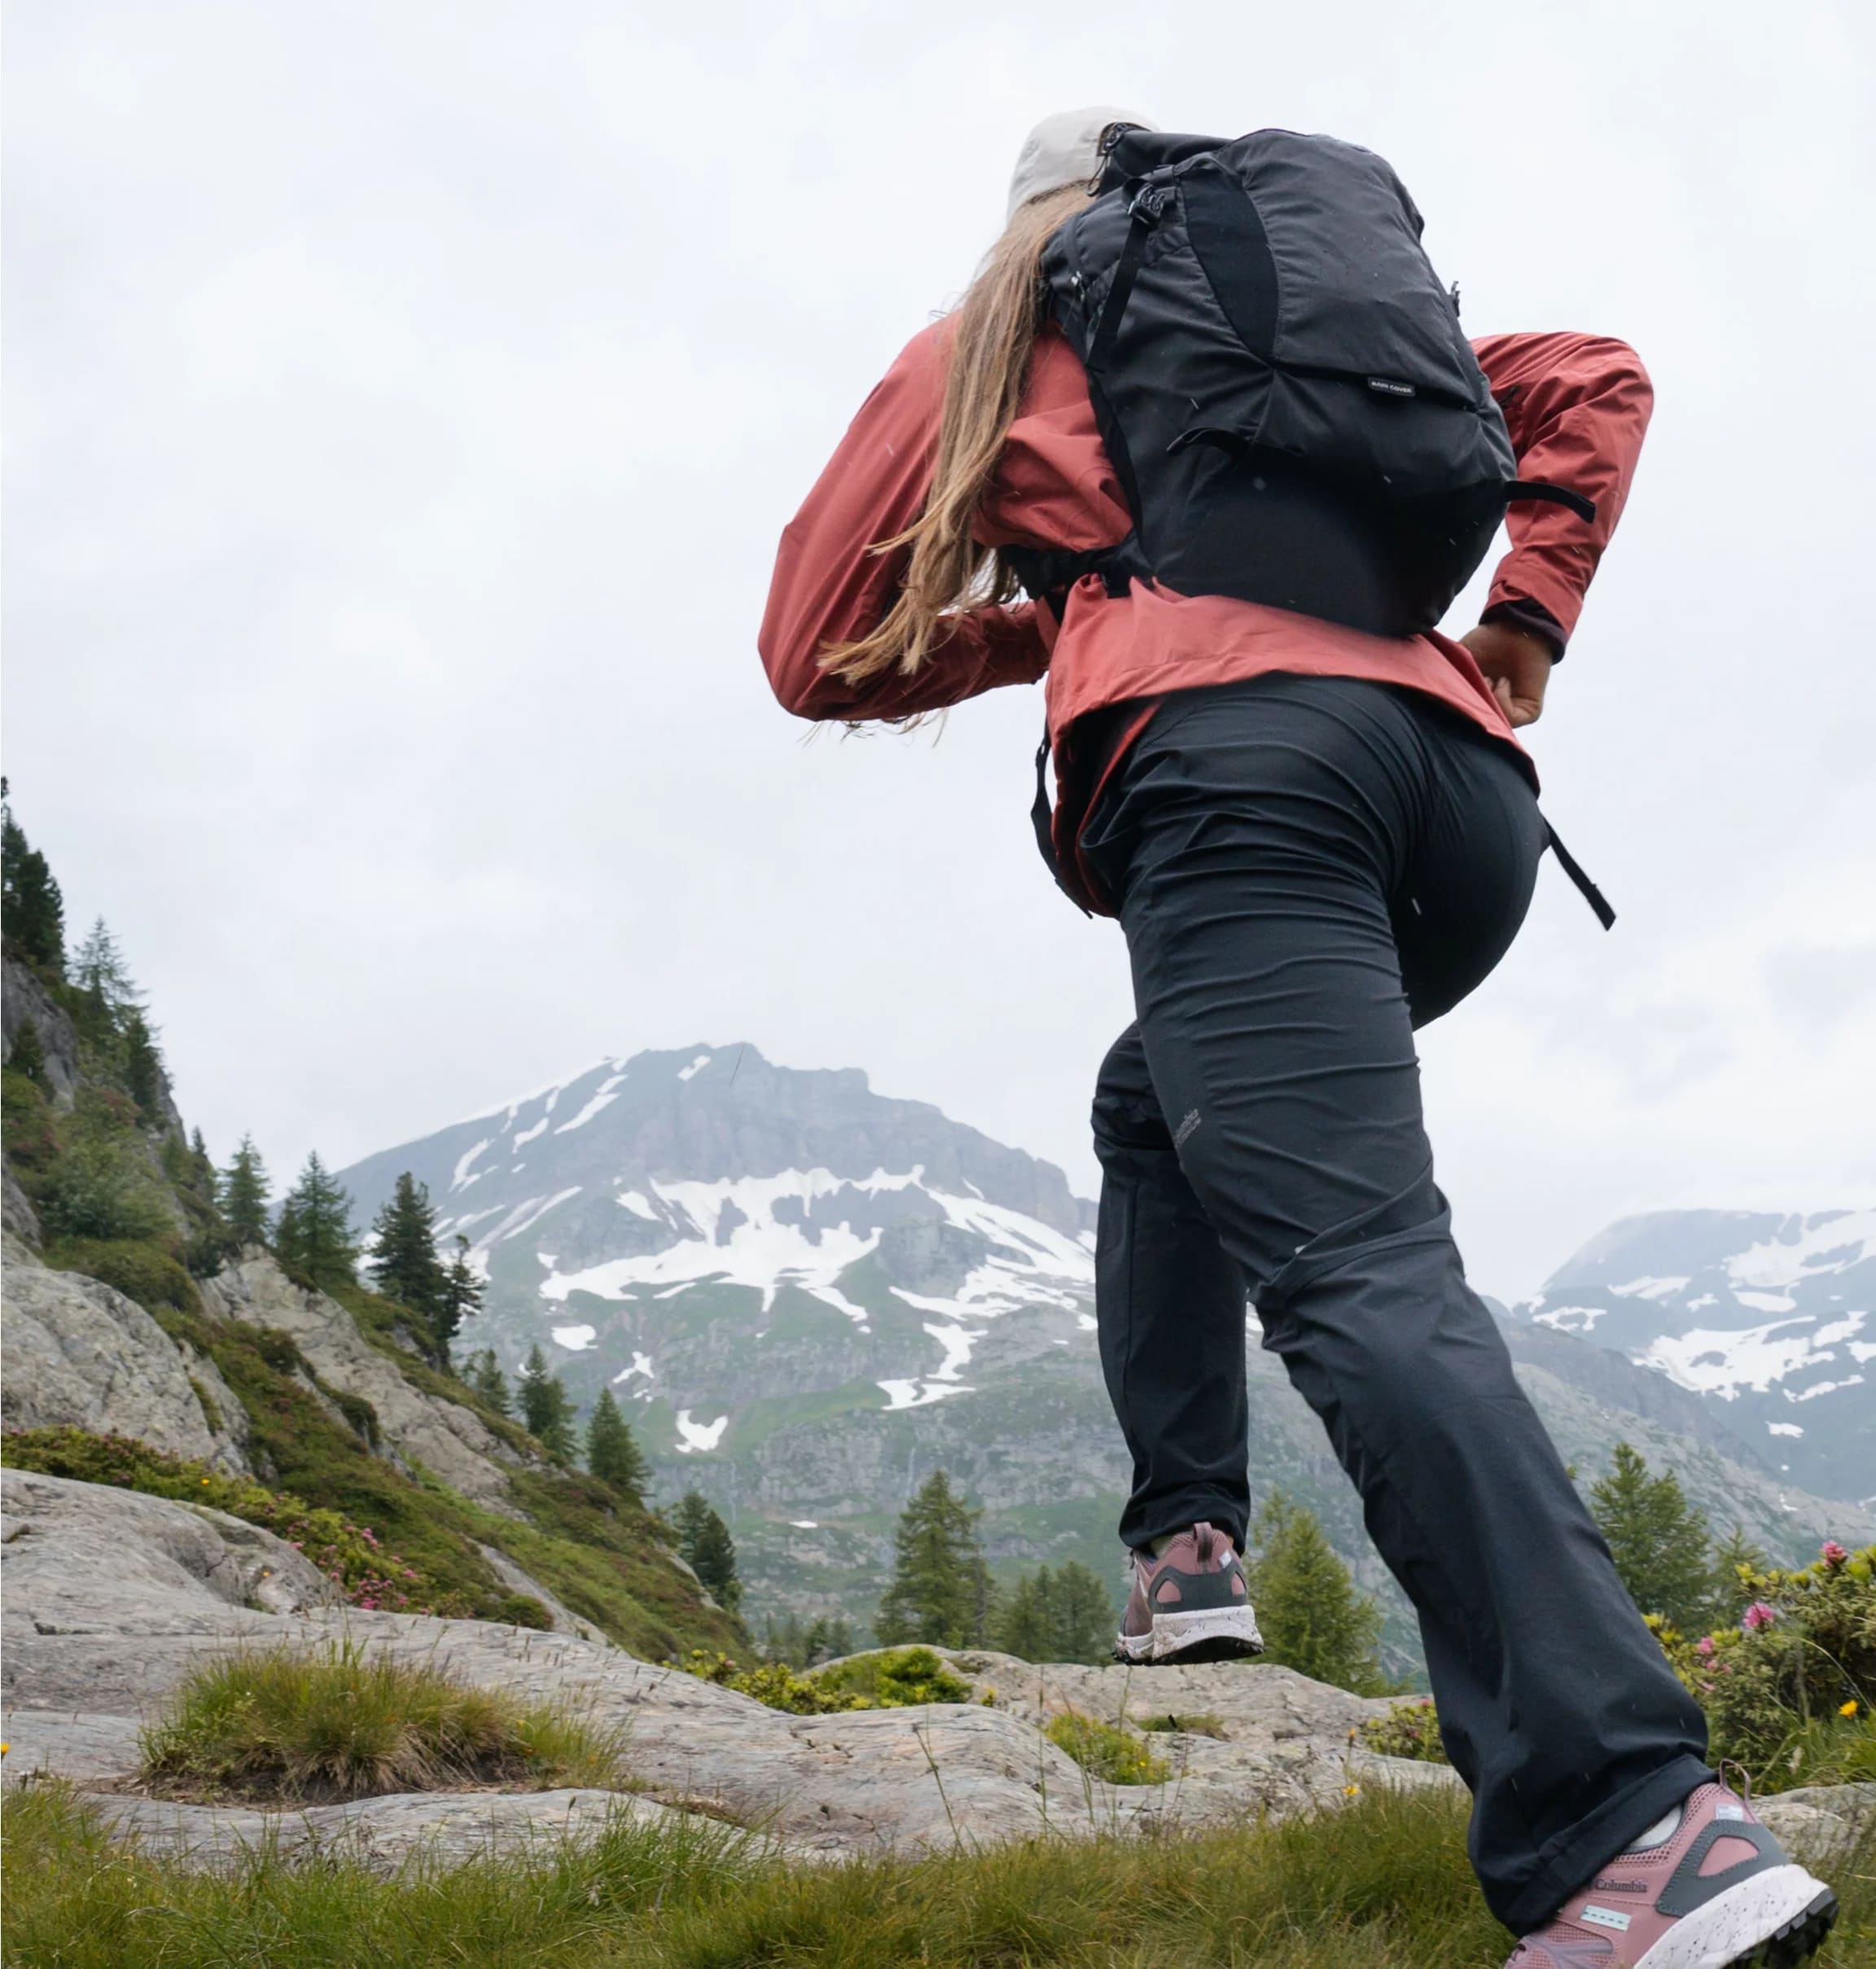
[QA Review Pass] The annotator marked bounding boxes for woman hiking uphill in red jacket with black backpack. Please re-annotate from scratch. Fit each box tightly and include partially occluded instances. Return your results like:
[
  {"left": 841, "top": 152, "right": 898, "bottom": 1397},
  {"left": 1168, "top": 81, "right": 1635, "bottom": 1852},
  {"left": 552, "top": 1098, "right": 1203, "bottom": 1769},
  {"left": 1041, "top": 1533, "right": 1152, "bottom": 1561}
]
[{"left": 760, "top": 108, "right": 1834, "bottom": 1969}]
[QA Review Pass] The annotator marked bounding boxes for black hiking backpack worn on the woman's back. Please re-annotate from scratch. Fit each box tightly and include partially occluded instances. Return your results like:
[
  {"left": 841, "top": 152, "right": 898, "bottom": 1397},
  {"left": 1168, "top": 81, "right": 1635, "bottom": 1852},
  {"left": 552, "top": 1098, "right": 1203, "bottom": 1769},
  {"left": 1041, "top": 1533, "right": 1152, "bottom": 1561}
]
[{"left": 1012, "top": 124, "right": 1594, "bottom": 636}]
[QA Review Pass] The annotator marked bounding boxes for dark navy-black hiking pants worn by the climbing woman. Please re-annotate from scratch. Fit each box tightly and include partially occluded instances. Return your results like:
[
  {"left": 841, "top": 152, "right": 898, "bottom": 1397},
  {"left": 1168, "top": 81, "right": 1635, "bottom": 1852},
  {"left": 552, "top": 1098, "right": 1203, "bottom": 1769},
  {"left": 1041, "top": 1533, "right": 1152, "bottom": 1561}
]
[{"left": 1083, "top": 675, "right": 1709, "bottom": 1930}]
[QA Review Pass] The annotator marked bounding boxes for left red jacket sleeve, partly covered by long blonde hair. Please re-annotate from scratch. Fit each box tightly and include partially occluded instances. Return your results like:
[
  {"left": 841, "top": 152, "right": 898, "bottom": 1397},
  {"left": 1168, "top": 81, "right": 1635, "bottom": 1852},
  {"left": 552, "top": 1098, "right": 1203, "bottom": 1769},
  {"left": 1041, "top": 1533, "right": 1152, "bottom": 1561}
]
[{"left": 758, "top": 321, "right": 1050, "bottom": 719}]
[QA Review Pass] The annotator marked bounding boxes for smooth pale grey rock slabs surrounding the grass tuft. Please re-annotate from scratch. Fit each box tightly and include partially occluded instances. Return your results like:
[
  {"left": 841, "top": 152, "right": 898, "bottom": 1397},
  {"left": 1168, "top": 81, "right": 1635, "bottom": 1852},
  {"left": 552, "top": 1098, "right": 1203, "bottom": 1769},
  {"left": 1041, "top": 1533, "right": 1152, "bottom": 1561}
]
[{"left": 0, "top": 1469, "right": 1876, "bottom": 1870}]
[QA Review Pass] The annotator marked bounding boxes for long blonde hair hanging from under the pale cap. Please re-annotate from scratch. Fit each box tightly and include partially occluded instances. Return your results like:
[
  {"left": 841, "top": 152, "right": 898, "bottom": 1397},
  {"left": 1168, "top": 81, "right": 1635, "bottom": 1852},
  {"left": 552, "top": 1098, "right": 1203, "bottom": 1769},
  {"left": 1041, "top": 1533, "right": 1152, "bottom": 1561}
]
[{"left": 821, "top": 185, "right": 1089, "bottom": 683}]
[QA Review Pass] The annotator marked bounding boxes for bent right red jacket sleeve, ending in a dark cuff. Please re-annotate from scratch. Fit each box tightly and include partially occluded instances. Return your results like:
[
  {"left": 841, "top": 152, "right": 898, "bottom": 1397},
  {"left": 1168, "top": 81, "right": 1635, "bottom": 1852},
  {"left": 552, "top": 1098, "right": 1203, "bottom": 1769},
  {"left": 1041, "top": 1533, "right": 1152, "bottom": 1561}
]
[{"left": 1472, "top": 335, "right": 1654, "bottom": 656}]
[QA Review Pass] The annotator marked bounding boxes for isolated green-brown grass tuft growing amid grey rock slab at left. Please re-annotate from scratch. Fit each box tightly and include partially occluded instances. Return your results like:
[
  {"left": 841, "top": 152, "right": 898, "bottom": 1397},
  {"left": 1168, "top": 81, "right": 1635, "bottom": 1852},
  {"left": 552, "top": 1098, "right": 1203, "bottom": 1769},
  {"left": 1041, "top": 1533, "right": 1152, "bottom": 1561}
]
[{"left": 143, "top": 1642, "right": 620, "bottom": 1801}]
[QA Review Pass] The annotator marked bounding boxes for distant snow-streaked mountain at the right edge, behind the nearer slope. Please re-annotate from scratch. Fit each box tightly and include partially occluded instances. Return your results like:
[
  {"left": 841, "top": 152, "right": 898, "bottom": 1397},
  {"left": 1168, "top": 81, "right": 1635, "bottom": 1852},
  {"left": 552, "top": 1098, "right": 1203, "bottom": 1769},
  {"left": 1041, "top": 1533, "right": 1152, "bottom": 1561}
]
[{"left": 1516, "top": 1211, "right": 1876, "bottom": 1498}]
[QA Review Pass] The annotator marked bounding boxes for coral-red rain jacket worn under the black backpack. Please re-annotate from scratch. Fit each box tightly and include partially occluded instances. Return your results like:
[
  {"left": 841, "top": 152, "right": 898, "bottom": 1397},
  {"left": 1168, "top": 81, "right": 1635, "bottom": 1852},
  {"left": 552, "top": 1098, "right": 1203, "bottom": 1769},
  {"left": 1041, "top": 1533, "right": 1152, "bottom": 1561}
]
[{"left": 758, "top": 319, "right": 1654, "bottom": 910}]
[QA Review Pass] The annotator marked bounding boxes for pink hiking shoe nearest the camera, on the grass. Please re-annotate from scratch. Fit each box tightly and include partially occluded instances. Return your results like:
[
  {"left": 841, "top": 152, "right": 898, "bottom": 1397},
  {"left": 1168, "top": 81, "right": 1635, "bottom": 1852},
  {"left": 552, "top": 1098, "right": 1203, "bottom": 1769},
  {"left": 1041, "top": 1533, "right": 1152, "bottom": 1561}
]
[{"left": 1506, "top": 1784, "right": 1837, "bottom": 1969}]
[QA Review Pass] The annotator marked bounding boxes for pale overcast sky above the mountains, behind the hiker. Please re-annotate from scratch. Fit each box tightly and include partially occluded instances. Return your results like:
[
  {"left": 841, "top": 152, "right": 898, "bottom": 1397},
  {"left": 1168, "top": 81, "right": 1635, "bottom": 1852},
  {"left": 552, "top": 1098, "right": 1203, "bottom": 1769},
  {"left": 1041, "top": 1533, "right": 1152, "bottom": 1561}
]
[{"left": 6, "top": 0, "right": 1876, "bottom": 1294}]
